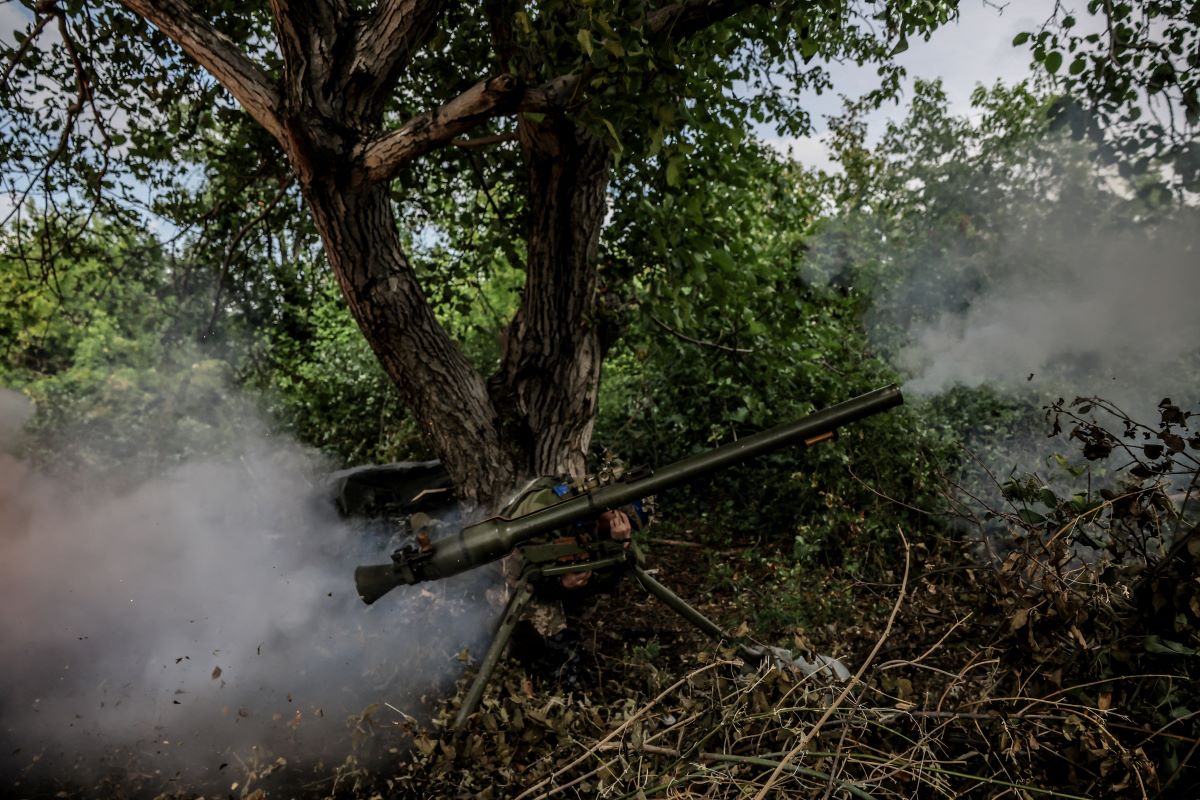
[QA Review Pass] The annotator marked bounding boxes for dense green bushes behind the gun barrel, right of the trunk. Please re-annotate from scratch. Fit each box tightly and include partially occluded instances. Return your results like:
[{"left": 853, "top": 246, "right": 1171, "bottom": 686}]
[{"left": 596, "top": 140, "right": 934, "bottom": 572}]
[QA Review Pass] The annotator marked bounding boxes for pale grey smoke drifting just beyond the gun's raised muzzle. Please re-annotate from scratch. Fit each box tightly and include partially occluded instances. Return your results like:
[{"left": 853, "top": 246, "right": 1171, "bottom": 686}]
[{"left": 899, "top": 215, "right": 1200, "bottom": 404}]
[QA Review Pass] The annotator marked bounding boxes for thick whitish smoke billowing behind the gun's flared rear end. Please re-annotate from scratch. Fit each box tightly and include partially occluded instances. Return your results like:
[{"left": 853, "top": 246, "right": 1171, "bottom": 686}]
[{"left": 0, "top": 390, "right": 491, "bottom": 790}]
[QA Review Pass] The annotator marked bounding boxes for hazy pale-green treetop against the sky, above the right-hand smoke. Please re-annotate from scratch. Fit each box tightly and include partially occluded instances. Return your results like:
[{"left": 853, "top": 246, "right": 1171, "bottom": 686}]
[{"left": 809, "top": 82, "right": 1154, "bottom": 363}]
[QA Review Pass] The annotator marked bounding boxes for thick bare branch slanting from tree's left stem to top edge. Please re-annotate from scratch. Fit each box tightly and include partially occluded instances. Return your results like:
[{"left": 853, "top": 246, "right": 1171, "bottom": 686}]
[{"left": 120, "top": 0, "right": 284, "bottom": 143}]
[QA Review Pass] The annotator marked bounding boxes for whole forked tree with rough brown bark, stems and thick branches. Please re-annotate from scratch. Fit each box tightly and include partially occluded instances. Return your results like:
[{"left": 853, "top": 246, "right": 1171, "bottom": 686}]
[{"left": 112, "top": 0, "right": 762, "bottom": 509}]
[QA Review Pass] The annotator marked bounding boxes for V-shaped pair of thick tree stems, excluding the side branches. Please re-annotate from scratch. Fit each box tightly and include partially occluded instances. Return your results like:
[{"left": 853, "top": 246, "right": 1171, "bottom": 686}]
[{"left": 265, "top": 4, "right": 608, "bottom": 512}]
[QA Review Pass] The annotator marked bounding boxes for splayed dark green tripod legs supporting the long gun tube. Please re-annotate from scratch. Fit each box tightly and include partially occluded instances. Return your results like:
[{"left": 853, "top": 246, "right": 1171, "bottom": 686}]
[{"left": 454, "top": 541, "right": 768, "bottom": 732}]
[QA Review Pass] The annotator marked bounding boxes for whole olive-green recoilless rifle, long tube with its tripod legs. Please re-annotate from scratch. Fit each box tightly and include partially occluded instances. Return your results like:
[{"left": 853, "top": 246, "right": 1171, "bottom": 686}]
[{"left": 354, "top": 385, "right": 904, "bottom": 729}]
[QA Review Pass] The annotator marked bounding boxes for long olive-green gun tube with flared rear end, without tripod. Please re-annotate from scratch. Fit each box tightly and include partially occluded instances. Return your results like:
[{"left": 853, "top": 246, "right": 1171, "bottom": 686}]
[{"left": 354, "top": 385, "right": 904, "bottom": 603}]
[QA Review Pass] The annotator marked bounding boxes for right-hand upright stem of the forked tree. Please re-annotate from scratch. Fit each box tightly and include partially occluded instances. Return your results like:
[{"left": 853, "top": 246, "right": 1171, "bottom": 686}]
[{"left": 490, "top": 116, "right": 610, "bottom": 476}]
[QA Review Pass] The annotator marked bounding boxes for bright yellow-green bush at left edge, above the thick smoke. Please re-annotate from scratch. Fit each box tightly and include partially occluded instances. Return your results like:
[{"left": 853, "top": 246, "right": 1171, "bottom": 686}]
[{"left": 0, "top": 215, "right": 260, "bottom": 479}]
